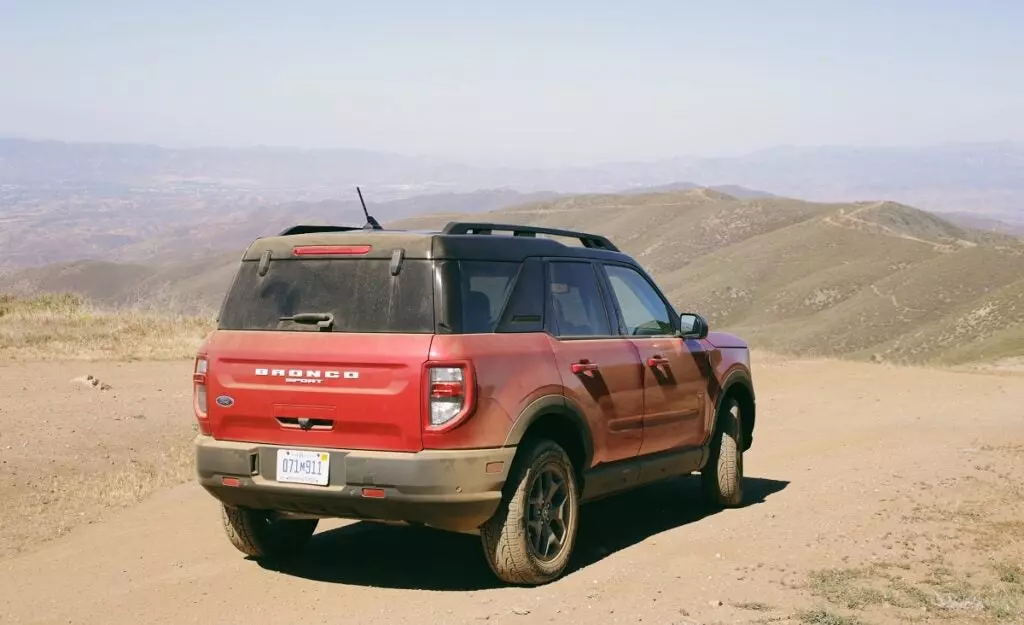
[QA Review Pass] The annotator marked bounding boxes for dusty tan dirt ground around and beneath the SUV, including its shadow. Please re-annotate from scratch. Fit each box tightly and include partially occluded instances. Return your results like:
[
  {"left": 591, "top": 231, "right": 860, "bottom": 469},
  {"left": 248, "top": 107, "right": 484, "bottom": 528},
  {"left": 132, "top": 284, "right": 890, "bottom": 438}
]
[{"left": 0, "top": 352, "right": 1024, "bottom": 625}]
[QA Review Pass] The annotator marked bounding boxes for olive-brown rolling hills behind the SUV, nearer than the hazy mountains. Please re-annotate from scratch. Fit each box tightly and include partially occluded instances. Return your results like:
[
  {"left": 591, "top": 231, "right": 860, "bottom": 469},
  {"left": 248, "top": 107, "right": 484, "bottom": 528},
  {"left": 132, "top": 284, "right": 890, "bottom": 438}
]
[{"left": 0, "top": 189, "right": 1024, "bottom": 363}]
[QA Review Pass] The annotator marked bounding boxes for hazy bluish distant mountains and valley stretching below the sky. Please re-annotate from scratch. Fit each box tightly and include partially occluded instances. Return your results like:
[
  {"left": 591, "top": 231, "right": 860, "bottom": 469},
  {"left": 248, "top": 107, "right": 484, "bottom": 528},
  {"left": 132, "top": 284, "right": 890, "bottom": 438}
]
[{"left": 0, "top": 135, "right": 1024, "bottom": 269}]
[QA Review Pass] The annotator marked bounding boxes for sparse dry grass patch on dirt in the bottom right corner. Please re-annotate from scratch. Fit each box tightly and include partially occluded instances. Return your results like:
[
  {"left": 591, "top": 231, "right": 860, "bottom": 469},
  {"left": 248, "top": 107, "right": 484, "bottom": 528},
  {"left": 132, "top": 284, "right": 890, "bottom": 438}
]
[{"left": 806, "top": 444, "right": 1024, "bottom": 624}]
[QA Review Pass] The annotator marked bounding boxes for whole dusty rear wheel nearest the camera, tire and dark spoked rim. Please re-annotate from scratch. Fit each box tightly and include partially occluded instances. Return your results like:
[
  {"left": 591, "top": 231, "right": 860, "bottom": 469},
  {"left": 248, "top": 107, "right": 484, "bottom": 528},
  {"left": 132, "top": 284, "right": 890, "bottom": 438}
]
[{"left": 480, "top": 441, "right": 580, "bottom": 585}]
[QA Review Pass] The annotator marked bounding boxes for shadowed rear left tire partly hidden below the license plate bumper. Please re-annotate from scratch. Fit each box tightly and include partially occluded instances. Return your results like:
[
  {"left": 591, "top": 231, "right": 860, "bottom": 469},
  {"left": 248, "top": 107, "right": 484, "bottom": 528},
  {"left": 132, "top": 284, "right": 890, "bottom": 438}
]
[{"left": 220, "top": 505, "right": 319, "bottom": 559}]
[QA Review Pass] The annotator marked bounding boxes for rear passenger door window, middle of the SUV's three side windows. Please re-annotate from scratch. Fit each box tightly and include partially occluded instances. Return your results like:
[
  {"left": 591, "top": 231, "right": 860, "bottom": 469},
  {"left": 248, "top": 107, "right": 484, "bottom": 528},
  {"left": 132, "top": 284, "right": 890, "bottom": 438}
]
[{"left": 548, "top": 261, "right": 611, "bottom": 336}]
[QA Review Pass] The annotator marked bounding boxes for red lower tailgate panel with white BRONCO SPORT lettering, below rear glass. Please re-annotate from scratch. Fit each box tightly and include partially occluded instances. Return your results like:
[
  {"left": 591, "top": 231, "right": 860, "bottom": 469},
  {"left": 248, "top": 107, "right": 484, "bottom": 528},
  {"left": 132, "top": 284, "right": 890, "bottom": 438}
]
[{"left": 207, "top": 331, "right": 432, "bottom": 451}]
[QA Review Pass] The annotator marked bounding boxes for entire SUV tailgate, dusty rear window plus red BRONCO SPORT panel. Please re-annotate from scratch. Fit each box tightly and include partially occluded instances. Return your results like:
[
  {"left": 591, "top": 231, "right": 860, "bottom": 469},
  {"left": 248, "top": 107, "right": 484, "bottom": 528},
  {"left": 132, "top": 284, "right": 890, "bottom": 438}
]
[{"left": 205, "top": 233, "right": 435, "bottom": 451}]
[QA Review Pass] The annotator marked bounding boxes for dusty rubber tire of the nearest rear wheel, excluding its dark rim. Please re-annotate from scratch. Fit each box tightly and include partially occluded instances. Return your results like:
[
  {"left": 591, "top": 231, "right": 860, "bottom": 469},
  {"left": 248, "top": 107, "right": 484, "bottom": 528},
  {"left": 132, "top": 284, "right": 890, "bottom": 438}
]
[{"left": 480, "top": 440, "right": 580, "bottom": 586}]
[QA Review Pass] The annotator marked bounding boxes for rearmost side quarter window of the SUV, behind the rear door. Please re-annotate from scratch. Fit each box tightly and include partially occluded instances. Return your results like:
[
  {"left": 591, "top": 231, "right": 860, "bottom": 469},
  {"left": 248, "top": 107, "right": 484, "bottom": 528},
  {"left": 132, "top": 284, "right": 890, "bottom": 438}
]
[{"left": 459, "top": 260, "right": 519, "bottom": 334}]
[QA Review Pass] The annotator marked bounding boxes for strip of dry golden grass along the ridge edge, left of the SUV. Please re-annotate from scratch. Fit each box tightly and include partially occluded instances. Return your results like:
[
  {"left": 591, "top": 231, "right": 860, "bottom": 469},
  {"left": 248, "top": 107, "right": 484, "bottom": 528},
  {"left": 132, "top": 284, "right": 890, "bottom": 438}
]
[{"left": 0, "top": 294, "right": 213, "bottom": 361}]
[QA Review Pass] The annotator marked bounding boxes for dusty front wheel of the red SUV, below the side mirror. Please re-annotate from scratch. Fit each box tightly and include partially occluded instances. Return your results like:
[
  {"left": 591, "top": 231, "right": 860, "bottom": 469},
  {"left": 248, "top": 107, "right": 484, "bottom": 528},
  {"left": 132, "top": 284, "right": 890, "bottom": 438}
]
[{"left": 700, "top": 399, "right": 743, "bottom": 508}]
